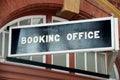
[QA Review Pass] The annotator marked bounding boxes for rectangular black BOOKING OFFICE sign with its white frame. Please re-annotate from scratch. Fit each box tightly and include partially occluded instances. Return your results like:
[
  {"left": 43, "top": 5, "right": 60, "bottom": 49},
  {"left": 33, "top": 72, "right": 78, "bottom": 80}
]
[{"left": 9, "top": 17, "right": 119, "bottom": 57}]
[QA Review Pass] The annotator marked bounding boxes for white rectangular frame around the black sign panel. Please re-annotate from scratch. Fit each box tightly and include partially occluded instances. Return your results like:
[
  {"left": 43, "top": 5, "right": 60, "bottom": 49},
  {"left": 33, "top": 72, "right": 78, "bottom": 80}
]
[{"left": 8, "top": 17, "right": 119, "bottom": 57}]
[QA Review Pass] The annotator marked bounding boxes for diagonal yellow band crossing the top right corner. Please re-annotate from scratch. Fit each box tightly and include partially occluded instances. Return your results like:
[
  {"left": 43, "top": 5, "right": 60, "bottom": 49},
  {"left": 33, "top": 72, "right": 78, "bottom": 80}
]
[{"left": 95, "top": 0, "right": 120, "bottom": 19}]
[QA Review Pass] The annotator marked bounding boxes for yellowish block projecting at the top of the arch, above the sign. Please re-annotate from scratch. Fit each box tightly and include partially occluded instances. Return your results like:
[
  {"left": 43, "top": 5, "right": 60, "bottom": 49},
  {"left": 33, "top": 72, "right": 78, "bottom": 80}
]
[{"left": 57, "top": 0, "right": 80, "bottom": 19}]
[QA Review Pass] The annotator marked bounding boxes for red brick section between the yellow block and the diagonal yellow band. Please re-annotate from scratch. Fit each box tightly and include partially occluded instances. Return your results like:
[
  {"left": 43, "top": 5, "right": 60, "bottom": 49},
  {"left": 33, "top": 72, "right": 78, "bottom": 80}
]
[{"left": 80, "top": 0, "right": 110, "bottom": 18}]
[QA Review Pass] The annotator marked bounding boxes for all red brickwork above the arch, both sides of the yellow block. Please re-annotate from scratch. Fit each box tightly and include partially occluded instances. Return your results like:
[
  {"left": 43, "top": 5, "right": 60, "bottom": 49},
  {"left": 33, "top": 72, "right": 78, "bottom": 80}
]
[{"left": 0, "top": 0, "right": 109, "bottom": 27}]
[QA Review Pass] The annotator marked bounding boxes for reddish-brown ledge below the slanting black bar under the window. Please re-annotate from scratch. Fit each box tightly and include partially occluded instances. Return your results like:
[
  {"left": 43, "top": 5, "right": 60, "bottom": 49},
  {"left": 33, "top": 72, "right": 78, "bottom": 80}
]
[{"left": 0, "top": 63, "right": 98, "bottom": 80}]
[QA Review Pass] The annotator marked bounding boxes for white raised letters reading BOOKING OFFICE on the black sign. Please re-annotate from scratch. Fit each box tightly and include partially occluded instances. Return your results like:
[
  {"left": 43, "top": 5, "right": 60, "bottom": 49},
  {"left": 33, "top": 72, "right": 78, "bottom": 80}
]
[{"left": 21, "top": 31, "right": 100, "bottom": 44}]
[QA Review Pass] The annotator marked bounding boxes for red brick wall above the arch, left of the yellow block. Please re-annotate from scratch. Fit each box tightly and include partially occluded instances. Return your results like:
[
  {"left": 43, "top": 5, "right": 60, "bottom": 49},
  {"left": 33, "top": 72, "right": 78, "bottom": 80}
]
[{"left": 0, "top": 0, "right": 63, "bottom": 27}]
